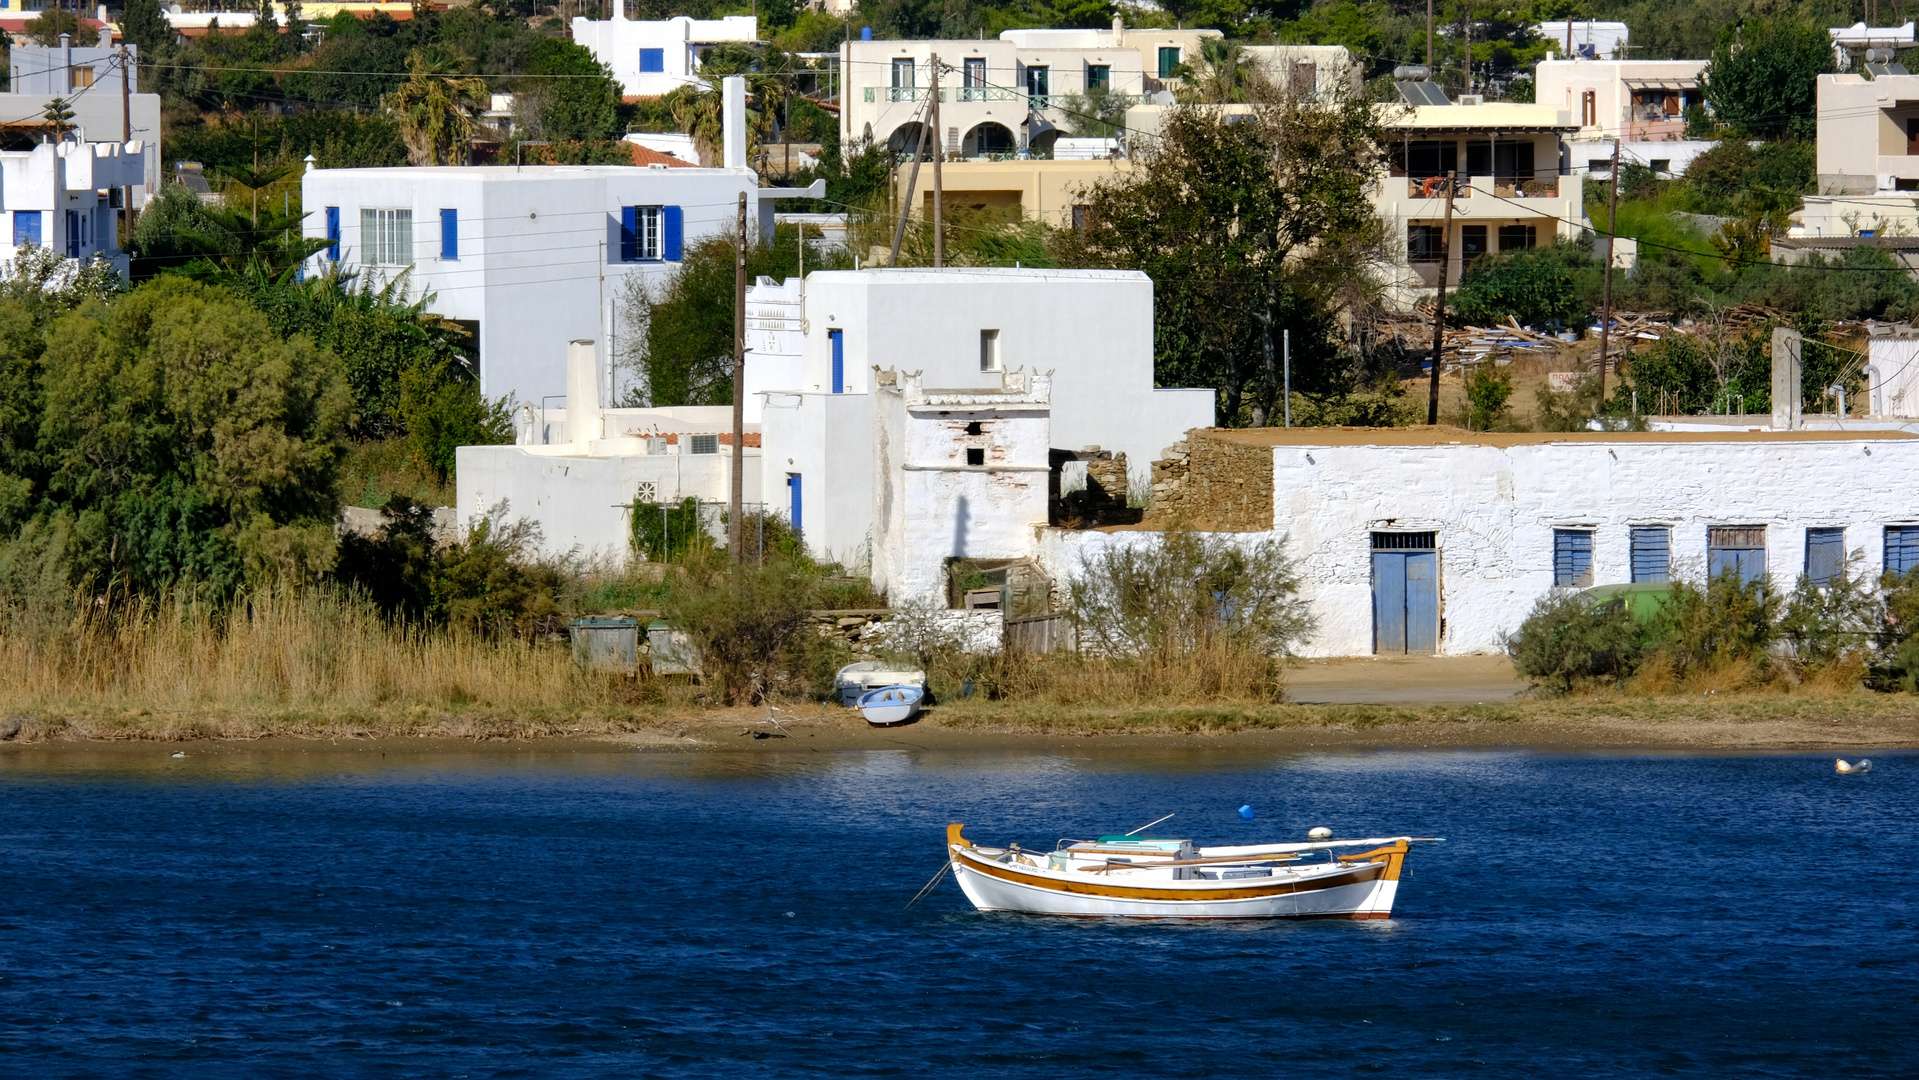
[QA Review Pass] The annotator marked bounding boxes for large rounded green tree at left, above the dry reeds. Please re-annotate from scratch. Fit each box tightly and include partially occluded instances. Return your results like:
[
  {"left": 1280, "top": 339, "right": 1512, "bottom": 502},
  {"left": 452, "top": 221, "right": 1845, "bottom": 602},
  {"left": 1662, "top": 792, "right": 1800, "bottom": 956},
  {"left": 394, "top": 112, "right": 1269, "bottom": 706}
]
[{"left": 38, "top": 278, "right": 351, "bottom": 591}]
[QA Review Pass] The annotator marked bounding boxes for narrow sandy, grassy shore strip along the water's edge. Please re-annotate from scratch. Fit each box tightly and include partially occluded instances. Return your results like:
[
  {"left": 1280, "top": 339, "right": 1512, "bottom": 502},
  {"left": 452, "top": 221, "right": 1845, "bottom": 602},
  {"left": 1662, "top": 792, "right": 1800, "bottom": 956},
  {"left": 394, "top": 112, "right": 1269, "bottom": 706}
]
[{"left": 0, "top": 694, "right": 1919, "bottom": 760}]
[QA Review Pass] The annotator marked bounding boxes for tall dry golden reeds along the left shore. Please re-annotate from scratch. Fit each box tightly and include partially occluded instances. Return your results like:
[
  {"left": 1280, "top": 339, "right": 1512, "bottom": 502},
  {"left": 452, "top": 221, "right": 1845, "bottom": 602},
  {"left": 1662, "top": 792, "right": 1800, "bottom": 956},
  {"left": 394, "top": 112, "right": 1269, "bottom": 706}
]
[{"left": 0, "top": 591, "right": 675, "bottom": 739}]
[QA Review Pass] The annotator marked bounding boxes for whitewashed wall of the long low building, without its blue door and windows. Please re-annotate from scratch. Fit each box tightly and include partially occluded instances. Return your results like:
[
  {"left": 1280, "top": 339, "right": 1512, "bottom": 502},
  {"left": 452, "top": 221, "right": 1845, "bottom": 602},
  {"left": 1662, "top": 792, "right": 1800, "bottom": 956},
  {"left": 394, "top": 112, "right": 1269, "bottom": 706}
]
[{"left": 1040, "top": 434, "right": 1919, "bottom": 656}]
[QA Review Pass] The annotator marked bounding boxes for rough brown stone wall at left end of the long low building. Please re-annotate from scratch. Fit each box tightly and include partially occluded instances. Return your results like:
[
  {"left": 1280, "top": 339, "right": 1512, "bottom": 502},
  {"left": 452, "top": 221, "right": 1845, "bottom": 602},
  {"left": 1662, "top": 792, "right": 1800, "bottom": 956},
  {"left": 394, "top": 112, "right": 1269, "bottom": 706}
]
[{"left": 1146, "top": 428, "right": 1272, "bottom": 533}]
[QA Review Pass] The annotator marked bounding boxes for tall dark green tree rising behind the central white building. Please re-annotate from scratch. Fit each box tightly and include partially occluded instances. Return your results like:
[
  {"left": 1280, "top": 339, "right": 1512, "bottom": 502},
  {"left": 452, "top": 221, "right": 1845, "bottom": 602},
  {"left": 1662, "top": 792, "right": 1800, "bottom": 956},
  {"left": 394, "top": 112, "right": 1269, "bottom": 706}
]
[{"left": 1059, "top": 94, "right": 1386, "bottom": 426}]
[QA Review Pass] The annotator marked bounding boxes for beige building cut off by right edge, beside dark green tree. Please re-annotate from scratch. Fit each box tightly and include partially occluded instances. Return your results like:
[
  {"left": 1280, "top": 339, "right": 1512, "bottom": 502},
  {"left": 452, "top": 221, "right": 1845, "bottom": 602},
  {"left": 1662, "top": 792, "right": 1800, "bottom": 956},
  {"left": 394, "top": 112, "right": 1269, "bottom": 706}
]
[{"left": 1817, "top": 63, "right": 1919, "bottom": 196}]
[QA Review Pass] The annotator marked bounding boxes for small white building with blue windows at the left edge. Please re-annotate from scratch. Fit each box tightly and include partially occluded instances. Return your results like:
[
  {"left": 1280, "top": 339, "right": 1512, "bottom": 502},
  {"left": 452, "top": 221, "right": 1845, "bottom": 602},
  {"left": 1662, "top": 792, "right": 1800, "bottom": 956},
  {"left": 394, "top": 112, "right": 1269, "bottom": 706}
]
[{"left": 0, "top": 142, "right": 144, "bottom": 274}]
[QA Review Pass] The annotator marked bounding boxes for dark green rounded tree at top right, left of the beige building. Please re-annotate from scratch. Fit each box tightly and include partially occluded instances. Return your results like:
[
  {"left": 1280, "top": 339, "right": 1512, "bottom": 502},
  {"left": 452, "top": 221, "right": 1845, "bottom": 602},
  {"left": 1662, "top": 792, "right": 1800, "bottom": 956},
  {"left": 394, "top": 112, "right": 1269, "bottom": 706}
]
[{"left": 1700, "top": 19, "right": 1833, "bottom": 138}]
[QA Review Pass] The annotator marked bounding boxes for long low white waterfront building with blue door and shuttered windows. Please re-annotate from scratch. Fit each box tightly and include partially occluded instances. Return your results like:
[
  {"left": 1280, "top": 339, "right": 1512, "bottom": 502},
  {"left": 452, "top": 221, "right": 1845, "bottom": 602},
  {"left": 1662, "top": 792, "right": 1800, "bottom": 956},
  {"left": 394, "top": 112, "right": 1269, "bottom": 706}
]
[{"left": 1040, "top": 428, "right": 1919, "bottom": 656}]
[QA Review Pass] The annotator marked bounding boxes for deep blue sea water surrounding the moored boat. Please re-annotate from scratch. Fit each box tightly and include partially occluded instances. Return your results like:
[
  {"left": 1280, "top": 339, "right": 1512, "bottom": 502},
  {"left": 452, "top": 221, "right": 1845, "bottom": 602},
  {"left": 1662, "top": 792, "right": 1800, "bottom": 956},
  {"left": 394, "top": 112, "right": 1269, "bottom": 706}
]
[{"left": 0, "top": 748, "right": 1919, "bottom": 1080}]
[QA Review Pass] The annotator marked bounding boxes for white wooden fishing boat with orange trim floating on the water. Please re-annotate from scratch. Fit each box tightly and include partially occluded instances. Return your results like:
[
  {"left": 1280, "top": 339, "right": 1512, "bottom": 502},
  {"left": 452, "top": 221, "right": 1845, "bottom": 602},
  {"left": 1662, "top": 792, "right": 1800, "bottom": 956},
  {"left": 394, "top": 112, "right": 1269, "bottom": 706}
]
[{"left": 946, "top": 825, "right": 1433, "bottom": 919}]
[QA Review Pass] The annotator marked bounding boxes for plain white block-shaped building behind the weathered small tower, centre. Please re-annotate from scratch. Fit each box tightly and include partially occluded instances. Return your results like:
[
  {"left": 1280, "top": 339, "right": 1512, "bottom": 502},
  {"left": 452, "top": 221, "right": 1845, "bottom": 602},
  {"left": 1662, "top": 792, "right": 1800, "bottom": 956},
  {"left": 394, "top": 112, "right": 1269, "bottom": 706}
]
[{"left": 746, "top": 269, "right": 1215, "bottom": 558}]
